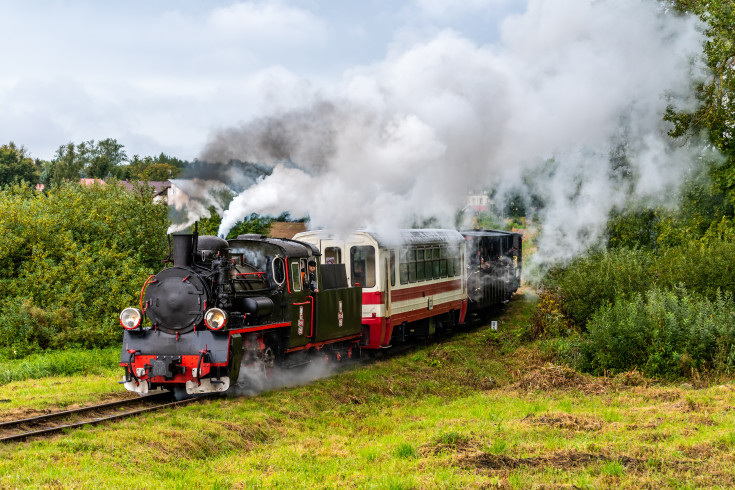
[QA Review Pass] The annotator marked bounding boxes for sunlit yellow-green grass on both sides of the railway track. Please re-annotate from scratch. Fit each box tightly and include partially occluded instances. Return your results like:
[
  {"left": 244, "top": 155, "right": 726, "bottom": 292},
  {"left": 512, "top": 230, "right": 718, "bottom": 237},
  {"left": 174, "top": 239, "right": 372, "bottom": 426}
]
[{"left": 0, "top": 293, "right": 735, "bottom": 489}]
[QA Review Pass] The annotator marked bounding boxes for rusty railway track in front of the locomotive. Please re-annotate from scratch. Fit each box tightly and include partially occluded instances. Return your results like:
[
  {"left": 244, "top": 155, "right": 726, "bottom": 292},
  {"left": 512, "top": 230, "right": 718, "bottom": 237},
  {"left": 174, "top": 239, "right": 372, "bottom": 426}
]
[{"left": 0, "top": 393, "right": 210, "bottom": 443}]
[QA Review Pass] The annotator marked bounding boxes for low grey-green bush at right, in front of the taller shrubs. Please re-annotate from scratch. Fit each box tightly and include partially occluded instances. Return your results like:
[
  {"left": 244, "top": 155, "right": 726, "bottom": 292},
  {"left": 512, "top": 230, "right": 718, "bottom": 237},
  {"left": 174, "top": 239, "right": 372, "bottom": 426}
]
[{"left": 580, "top": 289, "right": 735, "bottom": 378}]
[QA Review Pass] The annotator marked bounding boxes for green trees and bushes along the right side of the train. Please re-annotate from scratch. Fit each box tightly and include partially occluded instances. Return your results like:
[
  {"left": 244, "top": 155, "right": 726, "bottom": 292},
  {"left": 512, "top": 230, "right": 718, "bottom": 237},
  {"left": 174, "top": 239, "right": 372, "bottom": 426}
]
[{"left": 534, "top": 0, "right": 735, "bottom": 378}]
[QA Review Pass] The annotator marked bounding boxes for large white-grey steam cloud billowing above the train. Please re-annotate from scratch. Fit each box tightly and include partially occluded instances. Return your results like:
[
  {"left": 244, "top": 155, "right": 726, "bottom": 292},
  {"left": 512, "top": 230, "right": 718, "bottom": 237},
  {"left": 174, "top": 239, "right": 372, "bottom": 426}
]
[{"left": 172, "top": 0, "right": 703, "bottom": 268}]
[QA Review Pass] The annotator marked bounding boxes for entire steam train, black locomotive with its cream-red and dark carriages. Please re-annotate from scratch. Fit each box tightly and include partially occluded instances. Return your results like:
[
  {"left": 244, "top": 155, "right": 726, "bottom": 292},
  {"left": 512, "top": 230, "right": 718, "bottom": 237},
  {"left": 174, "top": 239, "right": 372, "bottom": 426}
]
[{"left": 120, "top": 229, "right": 521, "bottom": 396}]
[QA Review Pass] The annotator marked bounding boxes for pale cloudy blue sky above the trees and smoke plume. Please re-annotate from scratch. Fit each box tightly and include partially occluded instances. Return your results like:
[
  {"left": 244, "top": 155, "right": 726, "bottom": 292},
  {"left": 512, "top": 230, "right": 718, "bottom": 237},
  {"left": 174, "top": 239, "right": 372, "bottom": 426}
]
[{"left": 0, "top": 0, "right": 523, "bottom": 160}]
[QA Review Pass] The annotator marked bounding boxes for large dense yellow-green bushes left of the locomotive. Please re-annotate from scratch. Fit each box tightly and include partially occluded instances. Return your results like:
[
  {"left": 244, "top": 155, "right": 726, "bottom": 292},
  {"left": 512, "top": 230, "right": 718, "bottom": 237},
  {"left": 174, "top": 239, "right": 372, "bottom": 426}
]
[{"left": 0, "top": 184, "right": 168, "bottom": 357}]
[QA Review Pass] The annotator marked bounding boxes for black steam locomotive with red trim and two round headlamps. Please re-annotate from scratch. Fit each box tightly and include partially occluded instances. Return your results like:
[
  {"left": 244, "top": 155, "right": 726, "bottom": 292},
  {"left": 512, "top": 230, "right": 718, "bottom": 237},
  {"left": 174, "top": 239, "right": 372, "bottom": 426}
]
[{"left": 120, "top": 233, "right": 362, "bottom": 395}]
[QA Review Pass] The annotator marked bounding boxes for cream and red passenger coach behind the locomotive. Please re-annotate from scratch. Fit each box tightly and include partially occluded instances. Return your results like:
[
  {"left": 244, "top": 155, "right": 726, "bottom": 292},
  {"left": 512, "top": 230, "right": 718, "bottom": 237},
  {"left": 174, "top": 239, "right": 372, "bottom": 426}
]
[{"left": 294, "top": 229, "right": 467, "bottom": 349}]
